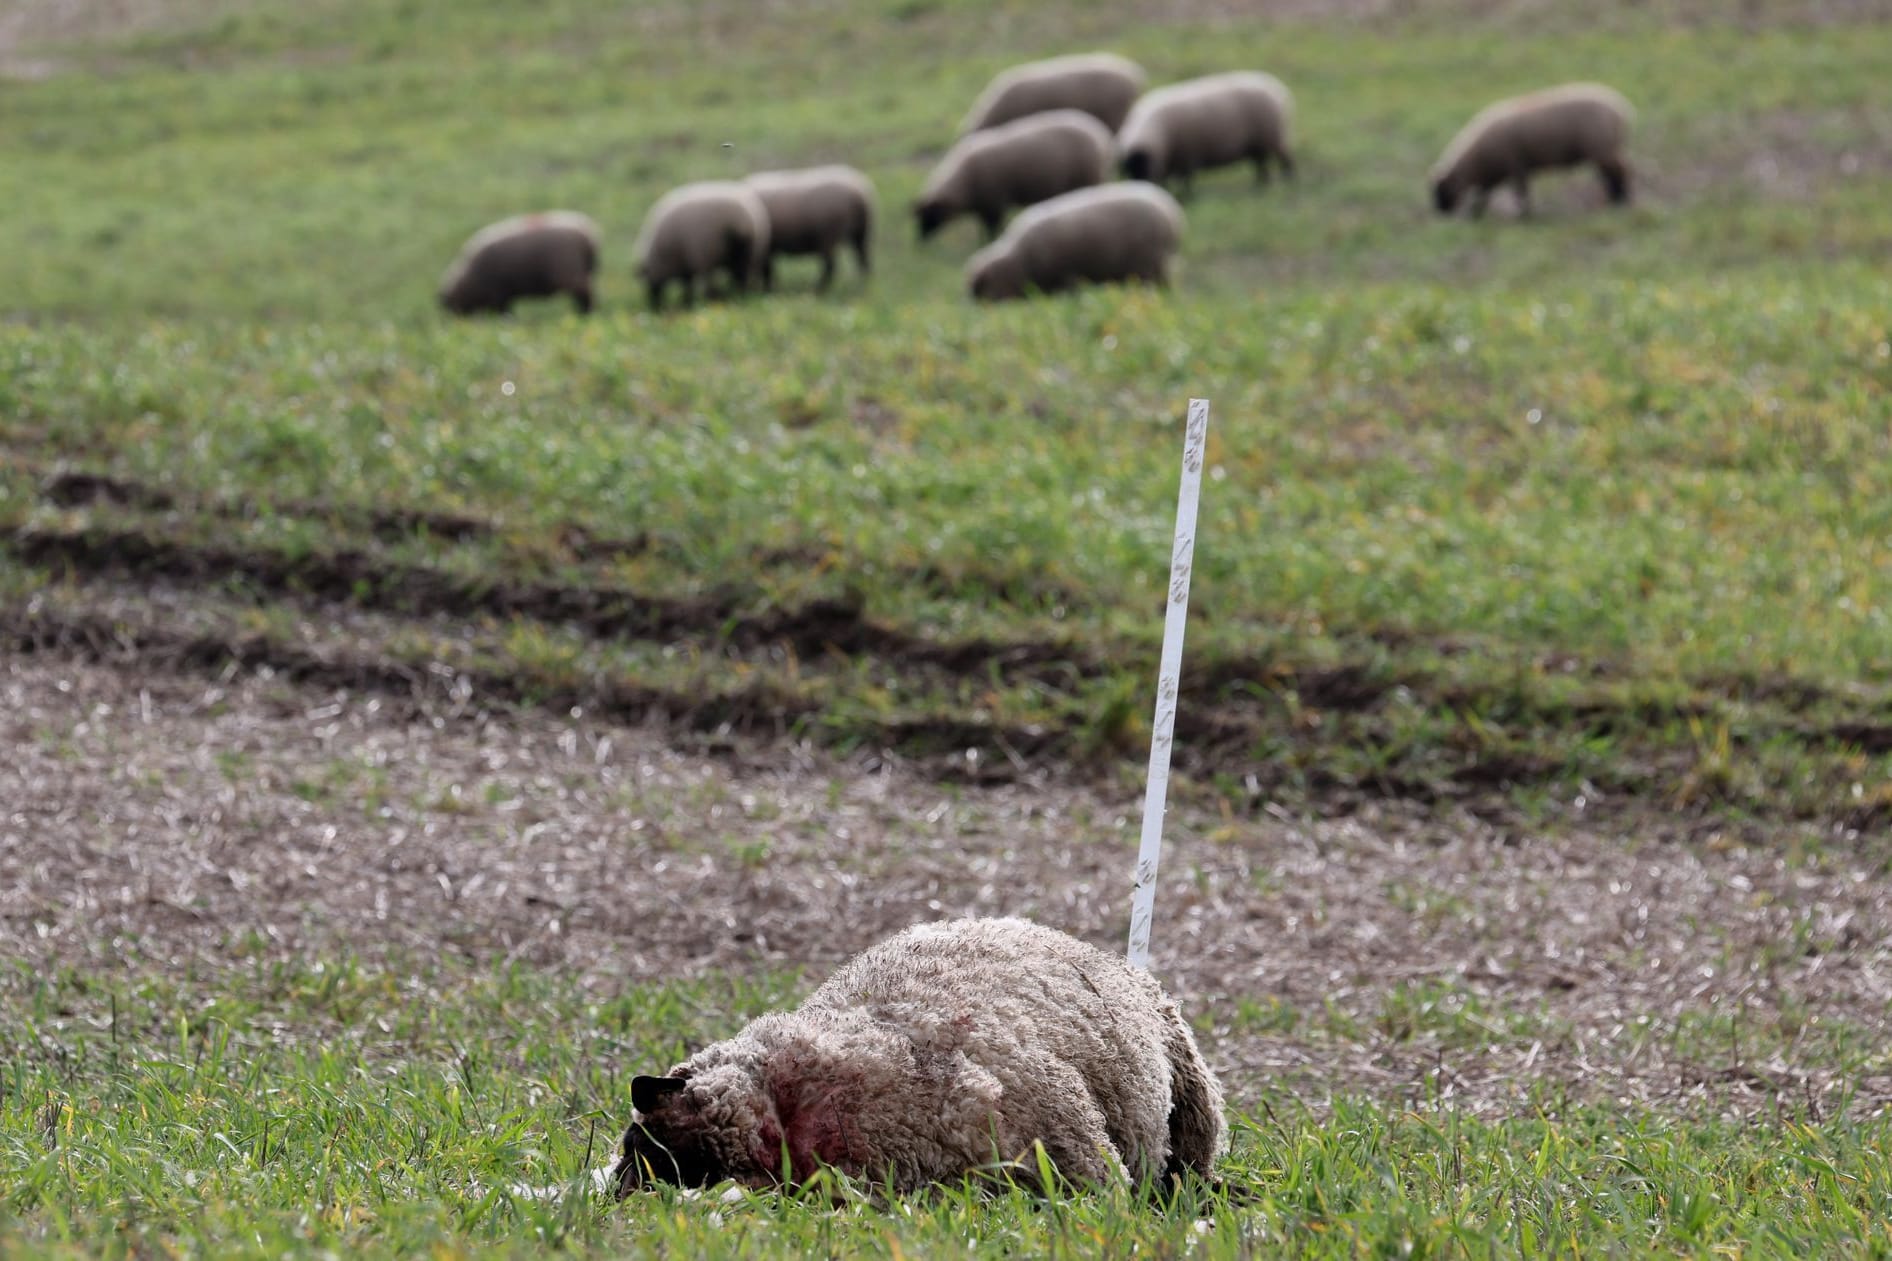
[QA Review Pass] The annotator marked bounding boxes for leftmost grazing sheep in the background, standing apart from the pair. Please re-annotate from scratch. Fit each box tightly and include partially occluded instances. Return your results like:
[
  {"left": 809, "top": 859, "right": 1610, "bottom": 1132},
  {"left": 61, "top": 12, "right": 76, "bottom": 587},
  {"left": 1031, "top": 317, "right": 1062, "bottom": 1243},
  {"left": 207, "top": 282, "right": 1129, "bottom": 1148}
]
[{"left": 439, "top": 210, "right": 598, "bottom": 314}]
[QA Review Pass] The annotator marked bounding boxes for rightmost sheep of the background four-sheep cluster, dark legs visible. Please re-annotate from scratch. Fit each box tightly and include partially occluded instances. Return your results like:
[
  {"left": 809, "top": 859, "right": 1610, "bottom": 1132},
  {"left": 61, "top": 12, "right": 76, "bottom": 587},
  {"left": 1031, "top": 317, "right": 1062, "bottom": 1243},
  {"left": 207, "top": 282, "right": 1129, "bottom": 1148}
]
[{"left": 1116, "top": 70, "right": 1294, "bottom": 187}]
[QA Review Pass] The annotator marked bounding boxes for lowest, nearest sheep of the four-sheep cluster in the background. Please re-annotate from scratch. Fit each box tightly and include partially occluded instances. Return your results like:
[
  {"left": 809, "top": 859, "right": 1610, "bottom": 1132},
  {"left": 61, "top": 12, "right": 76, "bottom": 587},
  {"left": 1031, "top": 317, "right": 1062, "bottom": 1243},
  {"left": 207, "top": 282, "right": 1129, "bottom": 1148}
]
[{"left": 965, "top": 184, "right": 1183, "bottom": 303}]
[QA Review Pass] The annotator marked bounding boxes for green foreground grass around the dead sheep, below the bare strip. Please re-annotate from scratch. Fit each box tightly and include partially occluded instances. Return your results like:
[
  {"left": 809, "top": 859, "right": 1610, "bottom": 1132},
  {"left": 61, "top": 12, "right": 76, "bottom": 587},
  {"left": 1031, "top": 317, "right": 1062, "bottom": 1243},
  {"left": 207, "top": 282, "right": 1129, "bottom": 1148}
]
[{"left": 0, "top": 960, "right": 1892, "bottom": 1257}]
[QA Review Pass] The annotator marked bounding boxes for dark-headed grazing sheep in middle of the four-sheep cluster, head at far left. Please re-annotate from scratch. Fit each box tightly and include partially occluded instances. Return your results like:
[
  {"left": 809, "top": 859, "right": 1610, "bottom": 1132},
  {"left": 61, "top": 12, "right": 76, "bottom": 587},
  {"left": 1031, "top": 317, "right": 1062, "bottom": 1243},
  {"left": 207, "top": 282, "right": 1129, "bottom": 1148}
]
[{"left": 914, "top": 110, "right": 1111, "bottom": 240}]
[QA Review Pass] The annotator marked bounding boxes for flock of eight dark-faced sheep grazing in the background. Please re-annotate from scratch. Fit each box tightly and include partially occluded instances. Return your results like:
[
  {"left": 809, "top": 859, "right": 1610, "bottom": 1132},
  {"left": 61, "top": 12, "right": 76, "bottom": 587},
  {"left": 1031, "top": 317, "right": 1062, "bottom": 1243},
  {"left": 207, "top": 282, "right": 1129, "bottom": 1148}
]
[{"left": 439, "top": 53, "right": 1635, "bottom": 314}]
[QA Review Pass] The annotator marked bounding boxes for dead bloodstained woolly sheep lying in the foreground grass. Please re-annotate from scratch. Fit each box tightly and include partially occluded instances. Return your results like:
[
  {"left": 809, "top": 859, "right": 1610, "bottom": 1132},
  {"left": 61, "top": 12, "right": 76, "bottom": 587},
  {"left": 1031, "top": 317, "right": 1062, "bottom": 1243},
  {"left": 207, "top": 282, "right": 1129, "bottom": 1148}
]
[{"left": 613, "top": 918, "right": 1226, "bottom": 1195}]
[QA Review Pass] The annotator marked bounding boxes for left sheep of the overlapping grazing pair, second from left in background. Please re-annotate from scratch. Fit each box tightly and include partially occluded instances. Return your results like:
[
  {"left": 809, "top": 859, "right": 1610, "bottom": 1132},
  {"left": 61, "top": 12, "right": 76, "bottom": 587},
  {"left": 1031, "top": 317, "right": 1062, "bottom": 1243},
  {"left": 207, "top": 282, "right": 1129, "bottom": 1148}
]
[{"left": 636, "top": 180, "right": 768, "bottom": 311}]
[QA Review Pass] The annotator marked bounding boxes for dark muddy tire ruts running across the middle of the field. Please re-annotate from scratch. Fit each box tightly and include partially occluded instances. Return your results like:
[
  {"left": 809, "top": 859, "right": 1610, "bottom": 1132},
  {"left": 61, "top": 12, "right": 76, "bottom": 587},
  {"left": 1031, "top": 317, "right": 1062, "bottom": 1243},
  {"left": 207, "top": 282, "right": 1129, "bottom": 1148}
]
[{"left": 18, "top": 471, "right": 1892, "bottom": 801}]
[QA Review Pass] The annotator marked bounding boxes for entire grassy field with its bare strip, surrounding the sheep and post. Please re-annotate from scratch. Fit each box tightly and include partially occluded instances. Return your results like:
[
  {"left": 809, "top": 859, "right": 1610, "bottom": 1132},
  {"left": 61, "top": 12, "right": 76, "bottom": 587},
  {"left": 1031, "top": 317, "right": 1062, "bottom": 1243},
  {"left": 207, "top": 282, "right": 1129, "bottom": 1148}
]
[{"left": 0, "top": 0, "right": 1892, "bottom": 1255}]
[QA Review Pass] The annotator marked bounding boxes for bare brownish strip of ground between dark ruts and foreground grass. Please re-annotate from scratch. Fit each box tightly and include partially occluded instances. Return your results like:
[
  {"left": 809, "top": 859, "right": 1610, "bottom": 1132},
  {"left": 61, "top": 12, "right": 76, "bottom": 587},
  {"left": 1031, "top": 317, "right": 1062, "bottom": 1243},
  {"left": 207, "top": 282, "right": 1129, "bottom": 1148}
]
[{"left": 0, "top": 655, "right": 1892, "bottom": 1113}]
